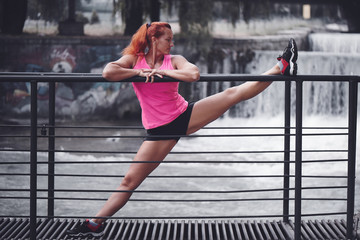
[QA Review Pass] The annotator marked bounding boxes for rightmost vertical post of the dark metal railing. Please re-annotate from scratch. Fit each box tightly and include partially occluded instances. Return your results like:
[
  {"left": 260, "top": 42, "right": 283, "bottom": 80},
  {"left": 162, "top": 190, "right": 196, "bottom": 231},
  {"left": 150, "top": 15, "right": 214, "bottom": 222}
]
[{"left": 346, "top": 80, "right": 358, "bottom": 239}]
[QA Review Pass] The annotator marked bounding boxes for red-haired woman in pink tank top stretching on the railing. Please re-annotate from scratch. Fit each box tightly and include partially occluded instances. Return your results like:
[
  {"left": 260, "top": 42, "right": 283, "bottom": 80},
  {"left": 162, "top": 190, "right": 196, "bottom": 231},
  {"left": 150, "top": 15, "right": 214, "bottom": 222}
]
[{"left": 68, "top": 22, "right": 297, "bottom": 236}]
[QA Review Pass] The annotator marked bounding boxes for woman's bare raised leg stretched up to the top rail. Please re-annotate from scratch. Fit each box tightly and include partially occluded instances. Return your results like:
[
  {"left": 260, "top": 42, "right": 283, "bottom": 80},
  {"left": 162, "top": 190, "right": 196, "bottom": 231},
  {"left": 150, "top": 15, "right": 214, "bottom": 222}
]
[{"left": 187, "top": 65, "right": 281, "bottom": 134}]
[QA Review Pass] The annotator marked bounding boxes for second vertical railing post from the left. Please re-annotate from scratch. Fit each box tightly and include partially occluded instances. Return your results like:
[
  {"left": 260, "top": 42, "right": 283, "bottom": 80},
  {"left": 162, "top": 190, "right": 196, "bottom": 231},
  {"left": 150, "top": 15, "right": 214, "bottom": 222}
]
[{"left": 48, "top": 82, "right": 55, "bottom": 217}]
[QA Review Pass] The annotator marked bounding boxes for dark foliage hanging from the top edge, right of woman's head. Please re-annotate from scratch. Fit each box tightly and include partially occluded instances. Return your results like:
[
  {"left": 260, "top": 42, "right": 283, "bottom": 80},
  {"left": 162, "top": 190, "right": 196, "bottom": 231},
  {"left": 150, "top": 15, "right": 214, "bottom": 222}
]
[{"left": 173, "top": 0, "right": 270, "bottom": 57}]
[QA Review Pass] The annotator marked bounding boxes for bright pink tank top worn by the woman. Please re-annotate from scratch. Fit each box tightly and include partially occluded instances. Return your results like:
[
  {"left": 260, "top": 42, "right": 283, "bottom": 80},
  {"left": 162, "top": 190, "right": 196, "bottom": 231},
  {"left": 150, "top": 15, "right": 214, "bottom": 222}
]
[{"left": 132, "top": 55, "right": 188, "bottom": 129}]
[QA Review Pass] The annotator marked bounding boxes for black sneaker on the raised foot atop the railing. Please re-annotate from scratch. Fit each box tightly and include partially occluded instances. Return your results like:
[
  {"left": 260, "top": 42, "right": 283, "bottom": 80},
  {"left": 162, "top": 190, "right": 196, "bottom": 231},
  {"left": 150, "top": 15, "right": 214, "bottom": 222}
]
[{"left": 277, "top": 38, "right": 297, "bottom": 76}]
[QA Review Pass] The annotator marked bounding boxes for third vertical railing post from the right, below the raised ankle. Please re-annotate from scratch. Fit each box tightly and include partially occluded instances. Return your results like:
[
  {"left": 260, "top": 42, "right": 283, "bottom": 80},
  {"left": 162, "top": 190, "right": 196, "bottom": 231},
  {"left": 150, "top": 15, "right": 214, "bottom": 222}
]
[{"left": 283, "top": 81, "right": 291, "bottom": 222}]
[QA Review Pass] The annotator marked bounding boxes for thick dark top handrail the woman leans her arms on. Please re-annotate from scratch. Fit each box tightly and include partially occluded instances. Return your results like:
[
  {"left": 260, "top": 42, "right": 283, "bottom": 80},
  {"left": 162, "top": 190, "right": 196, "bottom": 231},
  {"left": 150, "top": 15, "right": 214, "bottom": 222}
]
[{"left": 0, "top": 73, "right": 360, "bottom": 82}]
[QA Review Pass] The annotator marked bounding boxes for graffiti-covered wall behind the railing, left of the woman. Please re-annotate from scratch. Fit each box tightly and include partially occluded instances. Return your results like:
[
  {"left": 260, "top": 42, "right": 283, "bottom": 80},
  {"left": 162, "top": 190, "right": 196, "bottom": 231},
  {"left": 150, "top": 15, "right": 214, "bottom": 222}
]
[{"left": 0, "top": 45, "right": 141, "bottom": 118}]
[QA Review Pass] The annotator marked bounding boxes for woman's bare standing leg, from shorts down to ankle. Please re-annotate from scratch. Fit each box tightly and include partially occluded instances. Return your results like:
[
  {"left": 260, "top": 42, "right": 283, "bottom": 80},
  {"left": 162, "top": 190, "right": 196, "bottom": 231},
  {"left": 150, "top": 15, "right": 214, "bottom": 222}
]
[{"left": 92, "top": 140, "right": 176, "bottom": 223}]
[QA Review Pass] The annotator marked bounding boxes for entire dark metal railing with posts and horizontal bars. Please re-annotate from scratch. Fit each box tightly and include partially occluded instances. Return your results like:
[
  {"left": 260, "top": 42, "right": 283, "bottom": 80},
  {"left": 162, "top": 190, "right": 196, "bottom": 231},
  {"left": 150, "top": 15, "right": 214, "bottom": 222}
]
[{"left": 0, "top": 73, "right": 360, "bottom": 239}]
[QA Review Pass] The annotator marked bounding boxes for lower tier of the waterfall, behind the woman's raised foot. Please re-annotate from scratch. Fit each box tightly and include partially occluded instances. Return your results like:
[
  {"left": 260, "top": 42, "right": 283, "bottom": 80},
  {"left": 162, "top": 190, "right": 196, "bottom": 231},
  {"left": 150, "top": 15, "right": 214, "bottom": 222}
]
[{"left": 247, "top": 51, "right": 360, "bottom": 115}]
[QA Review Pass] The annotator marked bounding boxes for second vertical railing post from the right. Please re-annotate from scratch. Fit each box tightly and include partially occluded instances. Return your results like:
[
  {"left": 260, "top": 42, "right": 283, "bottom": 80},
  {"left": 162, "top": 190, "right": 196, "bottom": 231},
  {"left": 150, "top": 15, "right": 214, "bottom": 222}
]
[{"left": 295, "top": 79, "right": 303, "bottom": 240}]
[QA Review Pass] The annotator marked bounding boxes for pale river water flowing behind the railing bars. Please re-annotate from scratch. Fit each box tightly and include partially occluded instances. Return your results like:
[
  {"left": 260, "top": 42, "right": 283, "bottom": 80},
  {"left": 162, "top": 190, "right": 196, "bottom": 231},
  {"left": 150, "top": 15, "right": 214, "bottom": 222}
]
[{"left": 0, "top": 116, "right": 360, "bottom": 218}]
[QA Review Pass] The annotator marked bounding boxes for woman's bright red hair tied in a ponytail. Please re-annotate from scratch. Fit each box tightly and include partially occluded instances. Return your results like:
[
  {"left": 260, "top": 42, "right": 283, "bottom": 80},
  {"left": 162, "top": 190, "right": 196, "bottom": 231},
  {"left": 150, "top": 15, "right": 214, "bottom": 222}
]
[{"left": 122, "top": 22, "right": 171, "bottom": 55}]
